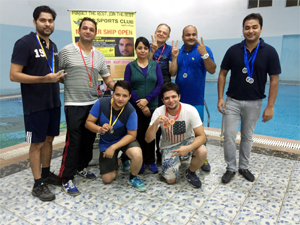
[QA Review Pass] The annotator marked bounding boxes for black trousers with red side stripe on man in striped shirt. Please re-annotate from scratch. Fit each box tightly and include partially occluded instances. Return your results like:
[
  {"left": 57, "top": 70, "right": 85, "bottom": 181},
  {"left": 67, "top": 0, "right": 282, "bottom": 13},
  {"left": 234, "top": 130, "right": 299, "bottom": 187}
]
[{"left": 58, "top": 105, "right": 96, "bottom": 181}]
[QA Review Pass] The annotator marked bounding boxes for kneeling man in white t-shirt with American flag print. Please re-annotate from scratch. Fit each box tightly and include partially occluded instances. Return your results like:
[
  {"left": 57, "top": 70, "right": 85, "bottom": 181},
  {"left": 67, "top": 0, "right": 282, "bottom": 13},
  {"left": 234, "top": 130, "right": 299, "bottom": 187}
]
[{"left": 145, "top": 82, "right": 207, "bottom": 188}]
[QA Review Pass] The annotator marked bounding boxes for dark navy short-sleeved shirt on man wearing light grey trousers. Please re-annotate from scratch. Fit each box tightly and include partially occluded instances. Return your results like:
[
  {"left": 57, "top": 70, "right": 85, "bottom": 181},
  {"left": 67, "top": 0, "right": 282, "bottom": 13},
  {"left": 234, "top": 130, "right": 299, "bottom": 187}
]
[{"left": 221, "top": 39, "right": 281, "bottom": 100}]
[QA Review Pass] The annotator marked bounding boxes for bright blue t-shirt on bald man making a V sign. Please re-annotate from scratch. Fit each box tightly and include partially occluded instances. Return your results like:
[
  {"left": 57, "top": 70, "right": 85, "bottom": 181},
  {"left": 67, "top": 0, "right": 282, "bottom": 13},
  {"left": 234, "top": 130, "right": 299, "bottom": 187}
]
[{"left": 175, "top": 43, "right": 214, "bottom": 105}]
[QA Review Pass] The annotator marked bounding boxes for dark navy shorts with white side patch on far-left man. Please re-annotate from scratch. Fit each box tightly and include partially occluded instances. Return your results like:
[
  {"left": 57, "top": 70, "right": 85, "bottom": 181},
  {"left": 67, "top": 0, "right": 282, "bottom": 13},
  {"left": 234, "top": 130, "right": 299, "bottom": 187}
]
[{"left": 24, "top": 107, "right": 60, "bottom": 143}]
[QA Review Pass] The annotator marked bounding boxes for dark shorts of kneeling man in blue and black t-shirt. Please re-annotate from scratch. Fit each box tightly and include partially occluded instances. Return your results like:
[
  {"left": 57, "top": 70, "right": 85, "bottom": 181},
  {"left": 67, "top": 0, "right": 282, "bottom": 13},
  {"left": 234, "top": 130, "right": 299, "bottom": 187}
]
[{"left": 99, "top": 140, "right": 141, "bottom": 175}]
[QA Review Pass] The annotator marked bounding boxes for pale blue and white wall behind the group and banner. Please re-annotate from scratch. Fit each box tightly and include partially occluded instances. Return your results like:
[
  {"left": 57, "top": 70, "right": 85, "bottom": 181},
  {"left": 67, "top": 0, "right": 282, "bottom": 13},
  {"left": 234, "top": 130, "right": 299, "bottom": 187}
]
[{"left": 0, "top": 0, "right": 300, "bottom": 95}]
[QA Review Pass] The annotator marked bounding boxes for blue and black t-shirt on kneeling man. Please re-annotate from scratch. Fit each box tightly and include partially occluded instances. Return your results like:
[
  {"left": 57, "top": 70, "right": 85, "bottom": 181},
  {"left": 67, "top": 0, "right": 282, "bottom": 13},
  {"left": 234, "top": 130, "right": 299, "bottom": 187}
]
[{"left": 90, "top": 97, "right": 137, "bottom": 152}]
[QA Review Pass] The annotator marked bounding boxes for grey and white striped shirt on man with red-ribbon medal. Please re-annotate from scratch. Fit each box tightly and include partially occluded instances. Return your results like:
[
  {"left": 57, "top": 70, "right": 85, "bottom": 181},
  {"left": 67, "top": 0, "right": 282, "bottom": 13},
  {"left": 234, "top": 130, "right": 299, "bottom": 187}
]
[{"left": 59, "top": 43, "right": 110, "bottom": 106}]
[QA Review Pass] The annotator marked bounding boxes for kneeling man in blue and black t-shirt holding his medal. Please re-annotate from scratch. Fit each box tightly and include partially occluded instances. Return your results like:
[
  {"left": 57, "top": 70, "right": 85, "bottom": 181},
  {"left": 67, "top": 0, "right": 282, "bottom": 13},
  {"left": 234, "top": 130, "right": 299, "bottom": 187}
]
[{"left": 85, "top": 81, "right": 146, "bottom": 191}]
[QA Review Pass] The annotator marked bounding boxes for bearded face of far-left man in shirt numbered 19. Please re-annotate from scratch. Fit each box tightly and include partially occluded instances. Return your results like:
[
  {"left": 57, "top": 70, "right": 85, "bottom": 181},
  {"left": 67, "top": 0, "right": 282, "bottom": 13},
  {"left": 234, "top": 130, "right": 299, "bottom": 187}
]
[{"left": 33, "top": 12, "right": 54, "bottom": 37}]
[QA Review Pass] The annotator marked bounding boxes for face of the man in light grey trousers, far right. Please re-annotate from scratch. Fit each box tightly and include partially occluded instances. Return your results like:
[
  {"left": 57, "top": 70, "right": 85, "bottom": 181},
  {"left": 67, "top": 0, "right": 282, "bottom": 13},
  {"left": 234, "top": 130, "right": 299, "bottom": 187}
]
[{"left": 243, "top": 19, "right": 262, "bottom": 42}]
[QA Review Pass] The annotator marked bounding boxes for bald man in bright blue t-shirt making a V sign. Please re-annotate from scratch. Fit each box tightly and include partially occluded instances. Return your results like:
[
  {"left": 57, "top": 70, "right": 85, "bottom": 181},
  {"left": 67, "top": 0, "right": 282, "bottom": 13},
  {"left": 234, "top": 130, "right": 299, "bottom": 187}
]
[{"left": 173, "top": 25, "right": 216, "bottom": 171}]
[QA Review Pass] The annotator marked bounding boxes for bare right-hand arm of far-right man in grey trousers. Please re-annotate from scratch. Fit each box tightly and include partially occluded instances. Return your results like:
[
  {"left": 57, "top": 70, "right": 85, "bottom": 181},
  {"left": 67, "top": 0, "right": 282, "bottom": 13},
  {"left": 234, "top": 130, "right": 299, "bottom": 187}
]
[{"left": 263, "top": 75, "right": 279, "bottom": 123}]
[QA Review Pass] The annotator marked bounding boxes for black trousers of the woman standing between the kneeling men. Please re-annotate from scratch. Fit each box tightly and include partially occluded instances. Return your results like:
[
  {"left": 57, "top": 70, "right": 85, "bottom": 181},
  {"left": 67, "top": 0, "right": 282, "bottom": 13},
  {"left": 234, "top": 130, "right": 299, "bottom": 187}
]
[{"left": 136, "top": 109, "right": 155, "bottom": 164}]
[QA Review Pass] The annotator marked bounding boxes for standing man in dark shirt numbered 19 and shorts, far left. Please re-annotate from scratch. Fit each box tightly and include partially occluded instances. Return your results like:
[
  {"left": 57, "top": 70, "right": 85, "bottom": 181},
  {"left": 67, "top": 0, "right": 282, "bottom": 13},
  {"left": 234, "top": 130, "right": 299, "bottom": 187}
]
[{"left": 10, "top": 6, "right": 66, "bottom": 201}]
